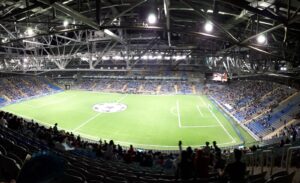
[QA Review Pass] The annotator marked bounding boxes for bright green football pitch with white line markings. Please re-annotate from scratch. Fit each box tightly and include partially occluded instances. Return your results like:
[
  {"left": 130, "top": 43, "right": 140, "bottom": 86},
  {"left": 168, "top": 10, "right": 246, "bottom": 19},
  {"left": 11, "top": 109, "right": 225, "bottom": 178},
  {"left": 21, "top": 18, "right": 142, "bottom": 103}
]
[{"left": 1, "top": 91, "right": 248, "bottom": 150}]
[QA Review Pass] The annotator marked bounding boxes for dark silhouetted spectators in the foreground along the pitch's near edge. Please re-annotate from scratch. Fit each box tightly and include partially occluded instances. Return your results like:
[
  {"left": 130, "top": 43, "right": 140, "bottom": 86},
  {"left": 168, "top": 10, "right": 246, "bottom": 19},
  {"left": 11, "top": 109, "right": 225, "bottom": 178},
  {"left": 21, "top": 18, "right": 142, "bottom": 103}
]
[{"left": 0, "top": 112, "right": 253, "bottom": 182}]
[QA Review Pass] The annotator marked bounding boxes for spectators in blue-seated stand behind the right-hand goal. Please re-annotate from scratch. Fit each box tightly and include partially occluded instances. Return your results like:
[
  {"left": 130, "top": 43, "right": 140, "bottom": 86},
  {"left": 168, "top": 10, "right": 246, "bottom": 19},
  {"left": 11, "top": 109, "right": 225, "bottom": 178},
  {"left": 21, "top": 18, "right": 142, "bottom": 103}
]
[{"left": 209, "top": 80, "right": 300, "bottom": 137}]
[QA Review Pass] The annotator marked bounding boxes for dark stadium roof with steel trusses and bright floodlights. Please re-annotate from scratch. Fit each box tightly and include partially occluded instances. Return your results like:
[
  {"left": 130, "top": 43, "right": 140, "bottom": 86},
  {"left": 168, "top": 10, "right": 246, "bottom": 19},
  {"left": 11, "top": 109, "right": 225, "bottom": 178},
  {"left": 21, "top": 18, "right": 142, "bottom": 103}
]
[{"left": 0, "top": 0, "right": 300, "bottom": 73}]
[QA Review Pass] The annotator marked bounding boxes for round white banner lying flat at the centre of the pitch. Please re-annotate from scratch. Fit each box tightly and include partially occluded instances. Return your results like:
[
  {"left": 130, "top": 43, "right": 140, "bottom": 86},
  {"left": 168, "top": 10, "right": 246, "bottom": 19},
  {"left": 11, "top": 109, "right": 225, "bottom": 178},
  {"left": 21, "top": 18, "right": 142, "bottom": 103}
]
[{"left": 93, "top": 102, "right": 127, "bottom": 113}]
